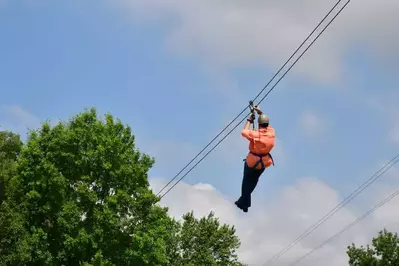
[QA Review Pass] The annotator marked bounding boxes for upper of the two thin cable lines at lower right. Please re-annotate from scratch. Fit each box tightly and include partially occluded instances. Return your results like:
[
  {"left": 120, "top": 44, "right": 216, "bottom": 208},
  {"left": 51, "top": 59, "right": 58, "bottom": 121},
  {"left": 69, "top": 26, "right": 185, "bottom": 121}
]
[{"left": 263, "top": 151, "right": 399, "bottom": 266}]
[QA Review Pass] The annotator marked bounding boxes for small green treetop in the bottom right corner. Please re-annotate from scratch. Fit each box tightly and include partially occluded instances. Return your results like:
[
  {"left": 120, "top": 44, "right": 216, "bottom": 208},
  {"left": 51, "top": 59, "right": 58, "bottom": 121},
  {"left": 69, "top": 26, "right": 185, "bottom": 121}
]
[{"left": 347, "top": 229, "right": 399, "bottom": 266}]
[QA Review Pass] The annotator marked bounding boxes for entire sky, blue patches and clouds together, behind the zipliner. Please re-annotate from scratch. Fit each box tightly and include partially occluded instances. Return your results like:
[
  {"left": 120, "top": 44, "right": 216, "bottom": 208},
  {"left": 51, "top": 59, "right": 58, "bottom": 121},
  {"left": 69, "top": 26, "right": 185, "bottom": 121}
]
[{"left": 0, "top": 0, "right": 399, "bottom": 266}]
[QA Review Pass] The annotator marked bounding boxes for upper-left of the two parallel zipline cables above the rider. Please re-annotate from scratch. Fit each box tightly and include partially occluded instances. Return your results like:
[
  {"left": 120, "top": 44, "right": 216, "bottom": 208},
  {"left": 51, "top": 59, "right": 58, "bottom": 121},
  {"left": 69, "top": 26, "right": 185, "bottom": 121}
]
[{"left": 157, "top": 0, "right": 343, "bottom": 196}]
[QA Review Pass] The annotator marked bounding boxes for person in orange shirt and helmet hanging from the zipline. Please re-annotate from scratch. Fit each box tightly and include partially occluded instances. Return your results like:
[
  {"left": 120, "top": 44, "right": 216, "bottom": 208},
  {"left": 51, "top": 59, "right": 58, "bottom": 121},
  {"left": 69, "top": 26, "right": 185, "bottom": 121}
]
[{"left": 235, "top": 102, "right": 276, "bottom": 212}]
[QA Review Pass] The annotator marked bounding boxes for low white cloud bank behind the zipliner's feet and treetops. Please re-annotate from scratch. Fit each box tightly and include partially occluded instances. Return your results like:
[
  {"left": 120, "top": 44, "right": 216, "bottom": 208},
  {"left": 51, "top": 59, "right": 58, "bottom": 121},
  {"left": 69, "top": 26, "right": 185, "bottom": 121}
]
[{"left": 151, "top": 175, "right": 398, "bottom": 266}]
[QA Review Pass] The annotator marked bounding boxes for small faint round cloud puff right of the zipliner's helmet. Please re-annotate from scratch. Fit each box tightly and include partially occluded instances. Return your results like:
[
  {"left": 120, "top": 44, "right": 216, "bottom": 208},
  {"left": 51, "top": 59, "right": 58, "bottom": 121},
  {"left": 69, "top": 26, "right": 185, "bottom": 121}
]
[{"left": 299, "top": 111, "right": 328, "bottom": 137}]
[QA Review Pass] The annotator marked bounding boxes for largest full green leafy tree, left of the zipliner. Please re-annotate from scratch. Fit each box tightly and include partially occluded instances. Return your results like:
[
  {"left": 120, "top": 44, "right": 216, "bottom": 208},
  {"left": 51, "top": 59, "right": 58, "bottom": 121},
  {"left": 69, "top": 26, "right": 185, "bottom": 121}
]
[{"left": 5, "top": 109, "right": 175, "bottom": 265}]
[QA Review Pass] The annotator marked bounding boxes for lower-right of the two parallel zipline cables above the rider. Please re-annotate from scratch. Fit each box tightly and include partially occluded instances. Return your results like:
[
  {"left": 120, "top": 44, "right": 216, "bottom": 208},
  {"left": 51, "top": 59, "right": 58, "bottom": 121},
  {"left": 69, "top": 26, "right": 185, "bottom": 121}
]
[{"left": 160, "top": 0, "right": 351, "bottom": 199}]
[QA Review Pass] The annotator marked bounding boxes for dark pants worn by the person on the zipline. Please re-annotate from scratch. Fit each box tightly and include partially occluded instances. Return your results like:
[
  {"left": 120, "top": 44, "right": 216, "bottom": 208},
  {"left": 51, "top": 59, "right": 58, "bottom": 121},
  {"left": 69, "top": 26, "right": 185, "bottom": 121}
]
[{"left": 236, "top": 162, "right": 265, "bottom": 211}]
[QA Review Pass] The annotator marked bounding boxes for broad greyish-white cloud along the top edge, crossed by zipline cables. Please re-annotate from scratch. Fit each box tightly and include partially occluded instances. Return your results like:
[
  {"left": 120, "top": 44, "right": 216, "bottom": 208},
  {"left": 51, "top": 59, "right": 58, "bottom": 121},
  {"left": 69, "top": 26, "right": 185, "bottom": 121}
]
[{"left": 112, "top": 0, "right": 399, "bottom": 82}]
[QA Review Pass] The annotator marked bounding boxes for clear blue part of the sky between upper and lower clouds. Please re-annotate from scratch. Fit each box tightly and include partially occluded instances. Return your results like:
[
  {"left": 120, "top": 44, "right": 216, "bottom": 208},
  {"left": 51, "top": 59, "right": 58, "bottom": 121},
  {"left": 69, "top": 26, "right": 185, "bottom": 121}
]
[{"left": 0, "top": 1, "right": 398, "bottom": 212}]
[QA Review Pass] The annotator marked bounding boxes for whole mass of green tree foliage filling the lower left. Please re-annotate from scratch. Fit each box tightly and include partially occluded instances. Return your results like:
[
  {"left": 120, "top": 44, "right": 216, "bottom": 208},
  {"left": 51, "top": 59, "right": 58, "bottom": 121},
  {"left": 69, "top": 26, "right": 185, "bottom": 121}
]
[{"left": 0, "top": 109, "right": 245, "bottom": 266}]
